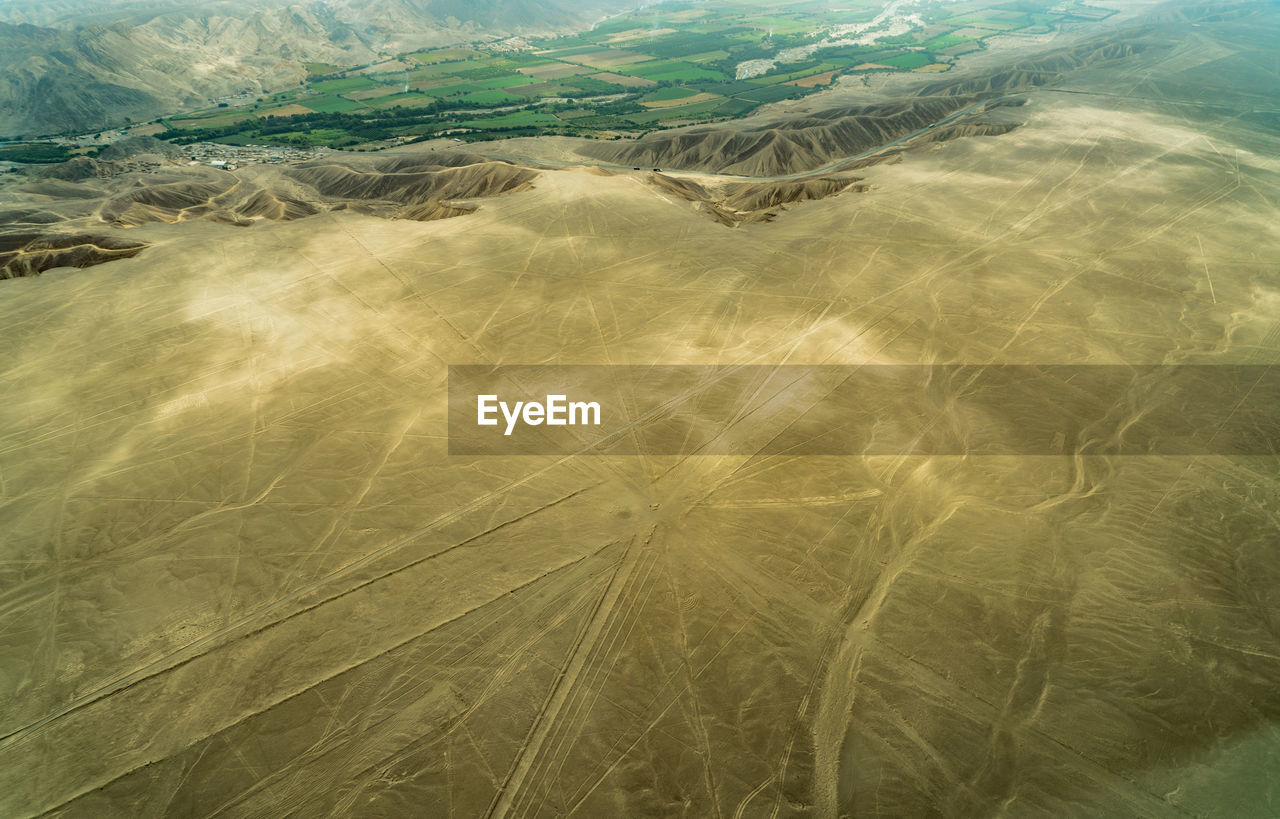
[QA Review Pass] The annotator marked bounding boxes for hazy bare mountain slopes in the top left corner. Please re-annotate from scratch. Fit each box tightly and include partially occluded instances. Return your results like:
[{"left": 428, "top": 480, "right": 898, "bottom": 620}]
[{"left": 0, "top": 0, "right": 635, "bottom": 136}]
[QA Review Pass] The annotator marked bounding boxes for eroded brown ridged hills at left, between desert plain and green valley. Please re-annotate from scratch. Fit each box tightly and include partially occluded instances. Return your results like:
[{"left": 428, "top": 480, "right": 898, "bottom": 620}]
[{"left": 0, "top": 152, "right": 538, "bottom": 279}]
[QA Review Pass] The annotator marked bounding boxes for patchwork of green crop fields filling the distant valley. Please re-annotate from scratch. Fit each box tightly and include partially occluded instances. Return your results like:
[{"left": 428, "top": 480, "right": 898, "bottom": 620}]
[{"left": 145, "top": 0, "right": 1090, "bottom": 147}]
